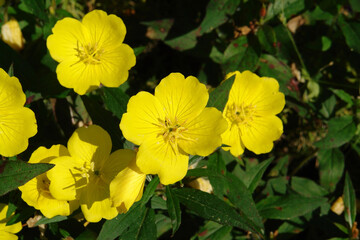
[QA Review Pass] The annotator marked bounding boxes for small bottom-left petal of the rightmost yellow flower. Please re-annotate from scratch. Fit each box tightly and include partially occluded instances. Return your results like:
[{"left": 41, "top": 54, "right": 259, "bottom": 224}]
[{"left": 221, "top": 121, "right": 245, "bottom": 157}]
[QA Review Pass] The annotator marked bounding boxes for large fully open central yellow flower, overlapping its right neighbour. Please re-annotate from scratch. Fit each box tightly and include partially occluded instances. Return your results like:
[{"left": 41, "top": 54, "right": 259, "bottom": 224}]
[{"left": 120, "top": 73, "right": 227, "bottom": 184}]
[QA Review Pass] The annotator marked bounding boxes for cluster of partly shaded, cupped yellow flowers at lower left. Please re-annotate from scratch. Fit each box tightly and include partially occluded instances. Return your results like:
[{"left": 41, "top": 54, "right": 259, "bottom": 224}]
[{"left": 19, "top": 125, "right": 146, "bottom": 222}]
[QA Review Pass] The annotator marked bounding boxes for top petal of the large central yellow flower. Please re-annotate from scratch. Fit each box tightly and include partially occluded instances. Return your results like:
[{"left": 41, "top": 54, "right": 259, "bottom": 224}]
[{"left": 155, "top": 73, "right": 209, "bottom": 124}]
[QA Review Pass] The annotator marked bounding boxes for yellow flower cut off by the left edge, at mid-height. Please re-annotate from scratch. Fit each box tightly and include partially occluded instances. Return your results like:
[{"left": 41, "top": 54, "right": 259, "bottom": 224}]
[{"left": 0, "top": 68, "right": 37, "bottom": 157}]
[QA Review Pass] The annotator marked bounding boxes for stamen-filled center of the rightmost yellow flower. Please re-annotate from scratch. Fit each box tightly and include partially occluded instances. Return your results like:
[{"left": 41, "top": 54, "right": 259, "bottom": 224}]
[{"left": 225, "top": 103, "right": 256, "bottom": 126}]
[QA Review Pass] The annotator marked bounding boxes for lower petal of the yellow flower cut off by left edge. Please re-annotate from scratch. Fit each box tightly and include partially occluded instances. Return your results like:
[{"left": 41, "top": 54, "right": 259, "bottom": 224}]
[{"left": 0, "top": 107, "right": 37, "bottom": 157}]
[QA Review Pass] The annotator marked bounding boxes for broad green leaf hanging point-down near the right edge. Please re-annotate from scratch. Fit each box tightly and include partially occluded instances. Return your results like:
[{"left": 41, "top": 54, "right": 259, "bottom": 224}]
[{"left": 318, "top": 148, "right": 345, "bottom": 192}]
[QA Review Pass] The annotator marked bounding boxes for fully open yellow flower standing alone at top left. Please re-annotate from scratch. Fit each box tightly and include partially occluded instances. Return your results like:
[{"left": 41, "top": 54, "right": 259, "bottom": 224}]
[{"left": 47, "top": 10, "right": 135, "bottom": 95}]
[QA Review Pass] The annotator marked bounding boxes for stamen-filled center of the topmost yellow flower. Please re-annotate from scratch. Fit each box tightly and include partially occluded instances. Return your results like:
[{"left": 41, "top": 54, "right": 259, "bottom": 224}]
[{"left": 75, "top": 43, "right": 104, "bottom": 64}]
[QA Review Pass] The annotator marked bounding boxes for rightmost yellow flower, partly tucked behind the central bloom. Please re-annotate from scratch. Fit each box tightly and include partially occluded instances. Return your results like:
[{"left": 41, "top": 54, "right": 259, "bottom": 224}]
[{"left": 221, "top": 71, "right": 285, "bottom": 156}]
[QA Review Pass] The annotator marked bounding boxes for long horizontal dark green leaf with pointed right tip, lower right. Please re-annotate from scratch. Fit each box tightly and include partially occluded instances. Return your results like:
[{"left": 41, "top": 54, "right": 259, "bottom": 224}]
[{"left": 256, "top": 194, "right": 327, "bottom": 219}]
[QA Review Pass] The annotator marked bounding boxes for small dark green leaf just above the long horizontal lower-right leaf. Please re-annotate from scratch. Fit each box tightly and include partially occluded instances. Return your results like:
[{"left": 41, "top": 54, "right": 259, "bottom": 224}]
[{"left": 291, "top": 177, "right": 329, "bottom": 197}]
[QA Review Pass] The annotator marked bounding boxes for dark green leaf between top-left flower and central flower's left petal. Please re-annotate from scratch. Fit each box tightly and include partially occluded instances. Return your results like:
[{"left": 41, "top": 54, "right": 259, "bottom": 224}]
[{"left": 102, "top": 87, "right": 130, "bottom": 119}]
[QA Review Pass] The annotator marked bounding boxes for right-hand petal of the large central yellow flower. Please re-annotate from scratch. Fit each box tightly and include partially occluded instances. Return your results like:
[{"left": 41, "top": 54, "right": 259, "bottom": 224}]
[{"left": 179, "top": 108, "right": 227, "bottom": 156}]
